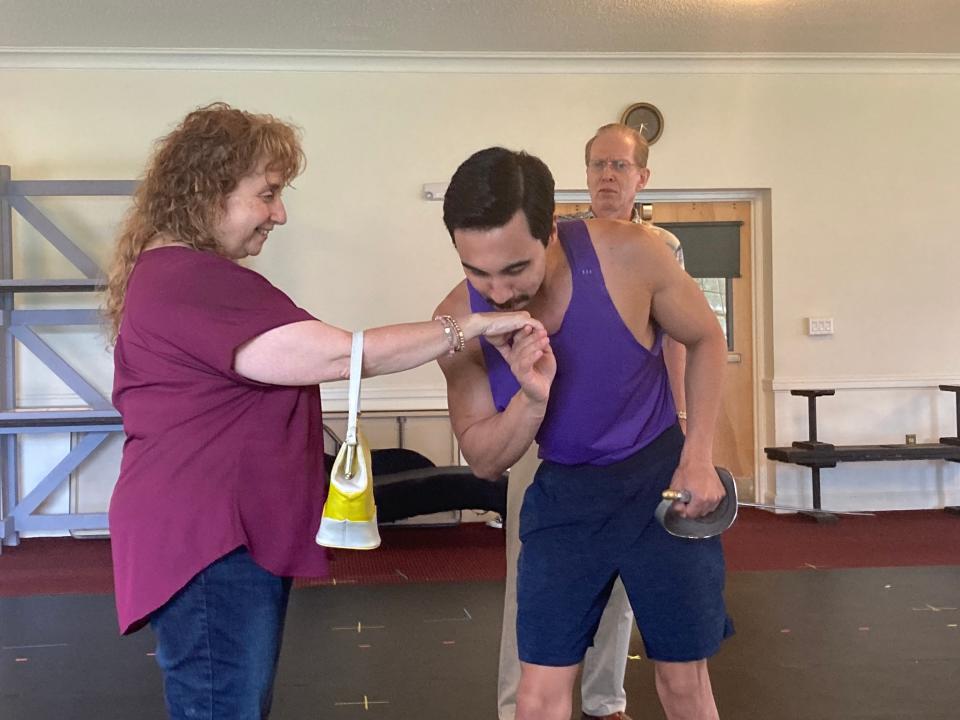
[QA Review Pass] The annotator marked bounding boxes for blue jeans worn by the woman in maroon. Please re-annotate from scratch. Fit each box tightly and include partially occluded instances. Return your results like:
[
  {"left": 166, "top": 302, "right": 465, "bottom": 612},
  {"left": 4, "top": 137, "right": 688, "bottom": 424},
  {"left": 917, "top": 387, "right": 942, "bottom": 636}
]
[{"left": 150, "top": 548, "right": 290, "bottom": 720}]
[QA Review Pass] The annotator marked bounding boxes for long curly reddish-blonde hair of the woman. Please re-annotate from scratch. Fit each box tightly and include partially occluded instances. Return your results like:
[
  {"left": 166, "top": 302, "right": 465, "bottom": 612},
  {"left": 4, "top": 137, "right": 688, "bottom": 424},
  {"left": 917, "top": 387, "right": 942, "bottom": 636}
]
[{"left": 104, "top": 102, "right": 306, "bottom": 342}]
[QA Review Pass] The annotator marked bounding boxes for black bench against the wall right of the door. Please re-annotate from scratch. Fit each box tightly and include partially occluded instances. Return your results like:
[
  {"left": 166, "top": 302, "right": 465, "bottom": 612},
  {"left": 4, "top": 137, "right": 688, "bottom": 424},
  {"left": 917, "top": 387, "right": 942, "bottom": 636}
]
[{"left": 763, "top": 385, "right": 960, "bottom": 517}]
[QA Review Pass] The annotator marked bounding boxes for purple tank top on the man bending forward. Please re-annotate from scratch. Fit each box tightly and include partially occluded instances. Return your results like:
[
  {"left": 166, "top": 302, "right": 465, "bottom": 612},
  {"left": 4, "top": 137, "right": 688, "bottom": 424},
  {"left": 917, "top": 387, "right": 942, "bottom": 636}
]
[{"left": 467, "top": 221, "right": 677, "bottom": 465}]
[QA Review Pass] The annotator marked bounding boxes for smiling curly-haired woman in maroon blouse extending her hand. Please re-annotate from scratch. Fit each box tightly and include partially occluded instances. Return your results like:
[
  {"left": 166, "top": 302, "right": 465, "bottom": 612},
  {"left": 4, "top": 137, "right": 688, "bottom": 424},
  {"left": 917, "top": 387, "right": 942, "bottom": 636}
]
[{"left": 106, "top": 103, "right": 535, "bottom": 720}]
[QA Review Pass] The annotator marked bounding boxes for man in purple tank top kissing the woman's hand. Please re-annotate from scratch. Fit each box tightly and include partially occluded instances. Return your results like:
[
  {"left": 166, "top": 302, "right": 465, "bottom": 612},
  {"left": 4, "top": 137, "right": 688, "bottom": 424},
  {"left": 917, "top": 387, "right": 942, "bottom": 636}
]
[{"left": 437, "top": 148, "right": 732, "bottom": 720}]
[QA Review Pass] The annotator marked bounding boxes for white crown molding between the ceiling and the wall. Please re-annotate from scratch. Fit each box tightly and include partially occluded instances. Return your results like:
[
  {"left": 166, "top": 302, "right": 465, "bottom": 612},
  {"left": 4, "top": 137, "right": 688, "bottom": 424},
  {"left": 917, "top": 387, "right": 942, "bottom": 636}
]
[{"left": 0, "top": 47, "right": 960, "bottom": 75}]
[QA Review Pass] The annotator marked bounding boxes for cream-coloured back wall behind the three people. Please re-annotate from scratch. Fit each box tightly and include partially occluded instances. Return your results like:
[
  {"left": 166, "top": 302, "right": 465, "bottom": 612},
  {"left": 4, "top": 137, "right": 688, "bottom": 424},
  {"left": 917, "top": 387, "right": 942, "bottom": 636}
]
[{"left": 0, "top": 61, "right": 960, "bottom": 506}]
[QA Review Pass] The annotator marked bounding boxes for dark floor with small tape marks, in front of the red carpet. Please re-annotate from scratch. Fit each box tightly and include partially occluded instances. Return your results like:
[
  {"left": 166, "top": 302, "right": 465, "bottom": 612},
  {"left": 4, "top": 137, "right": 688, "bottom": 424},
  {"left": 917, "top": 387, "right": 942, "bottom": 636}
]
[{"left": 0, "top": 566, "right": 960, "bottom": 720}]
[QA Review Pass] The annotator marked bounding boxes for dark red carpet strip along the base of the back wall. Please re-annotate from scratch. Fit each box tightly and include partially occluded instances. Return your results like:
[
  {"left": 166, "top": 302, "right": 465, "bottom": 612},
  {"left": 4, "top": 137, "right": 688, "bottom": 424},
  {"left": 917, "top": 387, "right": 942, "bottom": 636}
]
[{"left": 0, "top": 508, "right": 960, "bottom": 597}]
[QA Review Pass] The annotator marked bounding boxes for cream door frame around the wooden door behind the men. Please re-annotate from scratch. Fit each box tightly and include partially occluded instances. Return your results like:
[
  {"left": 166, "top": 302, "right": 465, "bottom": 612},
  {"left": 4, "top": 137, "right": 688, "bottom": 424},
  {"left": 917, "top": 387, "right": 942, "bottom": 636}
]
[{"left": 554, "top": 188, "right": 774, "bottom": 502}]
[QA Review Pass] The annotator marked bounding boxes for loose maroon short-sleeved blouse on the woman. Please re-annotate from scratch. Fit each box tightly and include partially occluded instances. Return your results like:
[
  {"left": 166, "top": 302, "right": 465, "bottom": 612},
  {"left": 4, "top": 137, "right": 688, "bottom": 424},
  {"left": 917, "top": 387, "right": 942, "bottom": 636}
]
[{"left": 110, "top": 246, "right": 326, "bottom": 633}]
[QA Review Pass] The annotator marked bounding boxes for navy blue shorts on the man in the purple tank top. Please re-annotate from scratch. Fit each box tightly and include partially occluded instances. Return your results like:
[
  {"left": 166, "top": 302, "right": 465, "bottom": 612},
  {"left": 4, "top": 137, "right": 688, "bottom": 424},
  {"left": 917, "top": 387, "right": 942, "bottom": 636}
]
[{"left": 517, "top": 426, "right": 733, "bottom": 667}]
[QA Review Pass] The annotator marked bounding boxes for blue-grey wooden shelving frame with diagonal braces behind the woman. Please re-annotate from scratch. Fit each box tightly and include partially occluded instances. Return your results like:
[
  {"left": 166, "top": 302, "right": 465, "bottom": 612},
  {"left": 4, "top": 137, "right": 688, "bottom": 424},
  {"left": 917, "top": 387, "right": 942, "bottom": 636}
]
[{"left": 0, "top": 165, "right": 136, "bottom": 550}]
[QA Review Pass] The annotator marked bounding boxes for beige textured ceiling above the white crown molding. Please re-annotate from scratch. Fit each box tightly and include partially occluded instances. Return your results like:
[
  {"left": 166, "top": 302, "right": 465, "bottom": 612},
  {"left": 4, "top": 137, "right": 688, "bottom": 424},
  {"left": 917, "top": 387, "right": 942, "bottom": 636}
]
[{"left": 0, "top": 0, "right": 960, "bottom": 55}]
